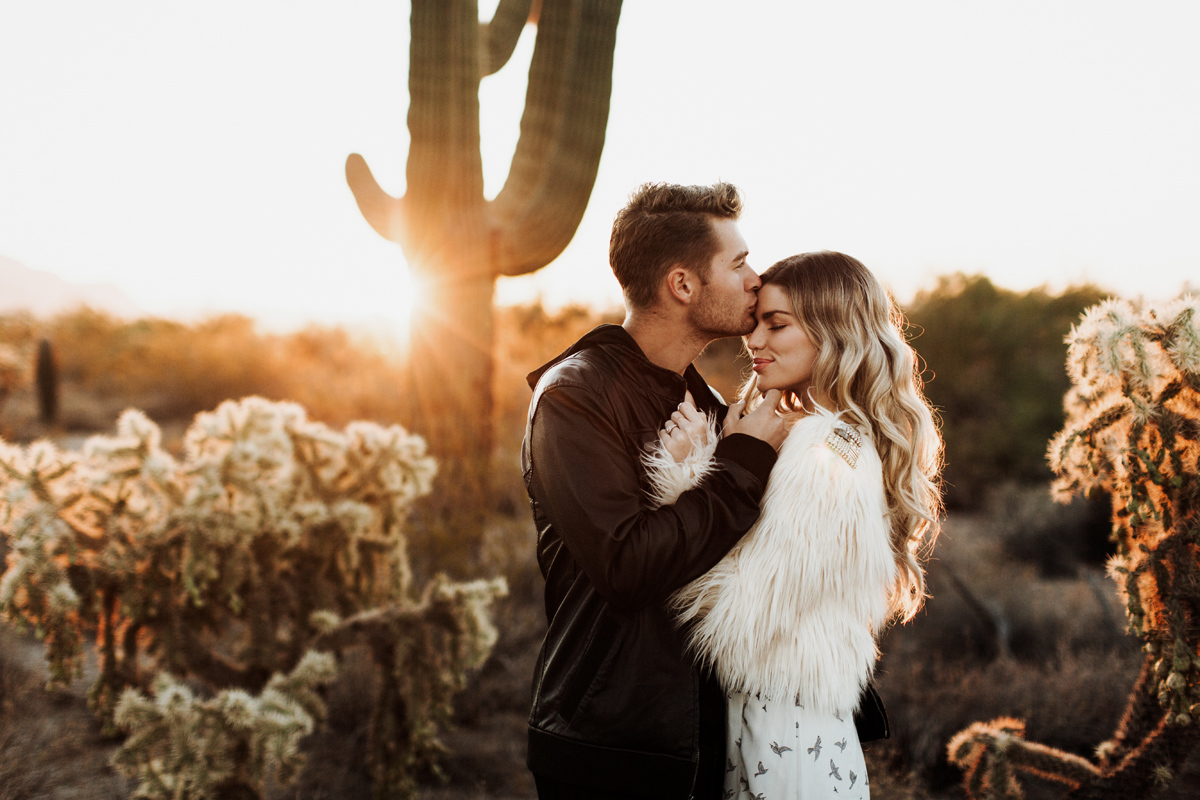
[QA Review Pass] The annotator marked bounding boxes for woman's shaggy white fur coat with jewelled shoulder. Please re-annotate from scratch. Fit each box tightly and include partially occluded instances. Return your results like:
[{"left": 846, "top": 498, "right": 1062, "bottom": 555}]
[{"left": 646, "top": 409, "right": 896, "bottom": 714}]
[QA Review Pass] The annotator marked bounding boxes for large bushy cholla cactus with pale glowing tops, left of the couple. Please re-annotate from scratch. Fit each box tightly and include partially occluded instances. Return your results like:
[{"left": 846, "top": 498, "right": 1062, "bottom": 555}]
[{"left": 0, "top": 397, "right": 504, "bottom": 796}]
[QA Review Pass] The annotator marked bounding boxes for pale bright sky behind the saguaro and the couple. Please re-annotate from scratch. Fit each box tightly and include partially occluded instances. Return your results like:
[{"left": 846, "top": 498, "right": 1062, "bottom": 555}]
[{"left": 0, "top": 0, "right": 1200, "bottom": 333}]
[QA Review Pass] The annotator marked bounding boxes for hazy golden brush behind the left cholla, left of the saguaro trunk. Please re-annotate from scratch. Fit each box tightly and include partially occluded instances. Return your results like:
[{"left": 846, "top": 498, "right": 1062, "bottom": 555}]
[{"left": 0, "top": 308, "right": 404, "bottom": 438}]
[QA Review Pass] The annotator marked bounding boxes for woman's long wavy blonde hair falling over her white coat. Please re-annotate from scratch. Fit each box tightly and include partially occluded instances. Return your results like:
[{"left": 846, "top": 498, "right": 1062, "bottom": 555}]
[{"left": 742, "top": 251, "right": 942, "bottom": 621}]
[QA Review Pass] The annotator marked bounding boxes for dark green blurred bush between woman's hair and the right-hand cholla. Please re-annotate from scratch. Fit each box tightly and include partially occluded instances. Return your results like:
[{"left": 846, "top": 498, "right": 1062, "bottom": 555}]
[{"left": 906, "top": 275, "right": 1104, "bottom": 507}]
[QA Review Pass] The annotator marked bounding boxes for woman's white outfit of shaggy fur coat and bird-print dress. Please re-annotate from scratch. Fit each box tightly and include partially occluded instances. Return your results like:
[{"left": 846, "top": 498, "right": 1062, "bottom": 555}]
[{"left": 647, "top": 409, "right": 896, "bottom": 800}]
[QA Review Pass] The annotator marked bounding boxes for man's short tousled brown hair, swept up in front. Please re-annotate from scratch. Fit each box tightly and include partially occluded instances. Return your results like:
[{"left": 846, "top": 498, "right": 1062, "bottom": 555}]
[{"left": 608, "top": 181, "right": 742, "bottom": 308}]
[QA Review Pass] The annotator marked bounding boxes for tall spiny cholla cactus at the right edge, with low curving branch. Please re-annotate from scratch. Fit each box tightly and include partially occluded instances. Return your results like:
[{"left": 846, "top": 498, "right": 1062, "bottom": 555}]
[{"left": 949, "top": 297, "right": 1200, "bottom": 800}]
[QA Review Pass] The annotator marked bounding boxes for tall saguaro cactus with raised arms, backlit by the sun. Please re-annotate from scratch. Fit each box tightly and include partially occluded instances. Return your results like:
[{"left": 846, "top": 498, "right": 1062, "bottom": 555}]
[{"left": 346, "top": 0, "right": 620, "bottom": 489}]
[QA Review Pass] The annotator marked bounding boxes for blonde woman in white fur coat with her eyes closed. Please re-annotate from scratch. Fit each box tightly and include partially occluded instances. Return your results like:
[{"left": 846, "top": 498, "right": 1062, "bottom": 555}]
[{"left": 648, "top": 252, "right": 941, "bottom": 800}]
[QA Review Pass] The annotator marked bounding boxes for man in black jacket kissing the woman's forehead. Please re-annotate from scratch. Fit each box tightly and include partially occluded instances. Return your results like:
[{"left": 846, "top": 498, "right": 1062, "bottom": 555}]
[{"left": 522, "top": 184, "right": 785, "bottom": 800}]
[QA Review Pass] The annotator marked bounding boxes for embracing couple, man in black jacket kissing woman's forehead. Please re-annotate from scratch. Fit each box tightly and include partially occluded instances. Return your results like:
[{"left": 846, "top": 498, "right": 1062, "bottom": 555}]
[{"left": 522, "top": 182, "right": 941, "bottom": 800}]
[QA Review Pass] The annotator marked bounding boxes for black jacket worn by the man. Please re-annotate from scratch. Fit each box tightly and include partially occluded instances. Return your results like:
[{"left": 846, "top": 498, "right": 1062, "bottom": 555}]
[{"left": 522, "top": 325, "right": 775, "bottom": 798}]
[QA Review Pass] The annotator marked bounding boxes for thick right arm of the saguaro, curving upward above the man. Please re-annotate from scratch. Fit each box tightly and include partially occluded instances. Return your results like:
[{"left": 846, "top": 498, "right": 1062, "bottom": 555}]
[{"left": 490, "top": 0, "right": 622, "bottom": 275}]
